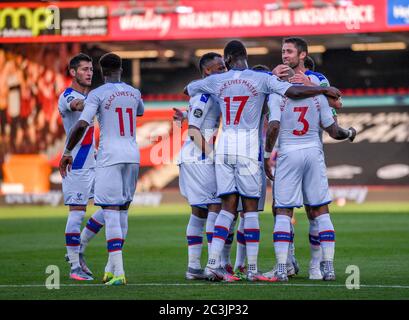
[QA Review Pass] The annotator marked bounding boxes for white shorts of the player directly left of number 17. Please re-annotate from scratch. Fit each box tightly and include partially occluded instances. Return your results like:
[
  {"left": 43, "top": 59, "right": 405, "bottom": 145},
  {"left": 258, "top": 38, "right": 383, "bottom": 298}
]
[{"left": 179, "top": 162, "right": 221, "bottom": 208}]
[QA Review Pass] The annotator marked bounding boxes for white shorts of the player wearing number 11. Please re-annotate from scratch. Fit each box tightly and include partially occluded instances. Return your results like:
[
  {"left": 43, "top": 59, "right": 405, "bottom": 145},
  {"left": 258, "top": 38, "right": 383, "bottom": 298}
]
[{"left": 94, "top": 163, "right": 139, "bottom": 206}]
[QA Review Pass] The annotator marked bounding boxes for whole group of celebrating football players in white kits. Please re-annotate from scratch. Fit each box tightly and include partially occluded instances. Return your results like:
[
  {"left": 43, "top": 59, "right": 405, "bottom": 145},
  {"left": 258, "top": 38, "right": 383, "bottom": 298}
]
[{"left": 58, "top": 38, "right": 356, "bottom": 285}]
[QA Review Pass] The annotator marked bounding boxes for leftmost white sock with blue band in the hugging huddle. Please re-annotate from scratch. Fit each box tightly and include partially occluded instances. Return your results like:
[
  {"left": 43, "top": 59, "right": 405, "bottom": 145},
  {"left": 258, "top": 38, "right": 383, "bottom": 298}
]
[{"left": 186, "top": 214, "right": 206, "bottom": 269}]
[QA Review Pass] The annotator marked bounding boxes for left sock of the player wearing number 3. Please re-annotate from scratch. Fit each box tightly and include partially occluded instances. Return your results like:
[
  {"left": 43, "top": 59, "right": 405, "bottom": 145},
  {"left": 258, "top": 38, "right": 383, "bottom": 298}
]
[{"left": 273, "top": 214, "right": 291, "bottom": 264}]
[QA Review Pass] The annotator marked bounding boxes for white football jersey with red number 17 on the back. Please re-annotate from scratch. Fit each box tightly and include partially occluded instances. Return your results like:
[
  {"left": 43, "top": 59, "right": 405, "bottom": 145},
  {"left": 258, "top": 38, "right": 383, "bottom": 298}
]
[{"left": 187, "top": 69, "right": 291, "bottom": 160}]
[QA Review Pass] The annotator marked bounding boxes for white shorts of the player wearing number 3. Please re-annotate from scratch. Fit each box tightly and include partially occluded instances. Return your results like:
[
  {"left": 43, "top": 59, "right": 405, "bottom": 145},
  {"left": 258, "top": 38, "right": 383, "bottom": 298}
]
[{"left": 273, "top": 148, "right": 331, "bottom": 208}]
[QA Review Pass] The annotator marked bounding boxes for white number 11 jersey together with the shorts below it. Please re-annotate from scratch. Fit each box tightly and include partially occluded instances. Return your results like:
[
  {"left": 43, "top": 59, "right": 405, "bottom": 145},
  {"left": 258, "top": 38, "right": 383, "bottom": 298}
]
[{"left": 80, "top": 82, "right": 144, "bottom": 206}]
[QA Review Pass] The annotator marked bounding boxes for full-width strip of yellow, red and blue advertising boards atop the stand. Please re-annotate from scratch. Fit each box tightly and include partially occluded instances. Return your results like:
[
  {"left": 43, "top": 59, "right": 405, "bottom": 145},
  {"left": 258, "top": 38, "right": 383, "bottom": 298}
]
[{"left": 0, "top": 0, "right": 409, "bottom": 43}]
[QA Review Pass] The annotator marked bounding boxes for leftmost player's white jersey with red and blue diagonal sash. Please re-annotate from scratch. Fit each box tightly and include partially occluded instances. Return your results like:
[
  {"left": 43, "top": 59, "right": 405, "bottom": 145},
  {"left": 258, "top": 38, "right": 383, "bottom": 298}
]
[{"left": 58, "top": 88, "right": 95, "bottom": 170}]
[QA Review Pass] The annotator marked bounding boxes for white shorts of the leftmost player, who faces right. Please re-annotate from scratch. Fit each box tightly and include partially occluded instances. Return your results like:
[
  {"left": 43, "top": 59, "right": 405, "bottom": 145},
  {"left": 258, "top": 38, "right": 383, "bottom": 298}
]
[{"left": 62, "top": 168, "right": 95, "bottom": 206}]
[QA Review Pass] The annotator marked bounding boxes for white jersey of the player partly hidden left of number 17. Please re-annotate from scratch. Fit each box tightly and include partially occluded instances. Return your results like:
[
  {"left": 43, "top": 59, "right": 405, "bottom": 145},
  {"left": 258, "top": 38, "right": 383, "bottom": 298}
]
[{"left": 180, "top": 94, "right": 220, "bottom": 163}]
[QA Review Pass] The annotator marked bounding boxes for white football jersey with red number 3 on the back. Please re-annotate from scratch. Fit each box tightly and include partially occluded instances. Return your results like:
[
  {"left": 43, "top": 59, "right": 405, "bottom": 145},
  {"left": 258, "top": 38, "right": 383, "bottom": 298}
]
[{"left": 268, "top": 94, "right": 335, "bottom": 152}]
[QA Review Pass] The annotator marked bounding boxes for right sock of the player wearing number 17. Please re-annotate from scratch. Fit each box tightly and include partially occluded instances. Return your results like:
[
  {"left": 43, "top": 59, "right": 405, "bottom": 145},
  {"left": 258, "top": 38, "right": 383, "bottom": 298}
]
[{"left": 244, "top": 212, "right": 260, "bottom": 273}]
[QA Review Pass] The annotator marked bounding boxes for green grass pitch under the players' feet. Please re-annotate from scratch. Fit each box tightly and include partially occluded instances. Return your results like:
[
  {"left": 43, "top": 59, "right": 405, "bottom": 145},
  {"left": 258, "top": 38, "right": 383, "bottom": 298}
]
[{"left": 0, "top": 202, "right": 409, "bottom": 300}]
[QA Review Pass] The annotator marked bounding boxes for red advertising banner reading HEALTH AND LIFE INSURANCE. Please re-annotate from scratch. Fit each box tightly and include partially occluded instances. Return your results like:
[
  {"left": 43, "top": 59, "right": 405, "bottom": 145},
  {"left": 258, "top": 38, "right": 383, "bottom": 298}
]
[{"left": 110, "top": 0, "right": 402, "bottom": 40}]
